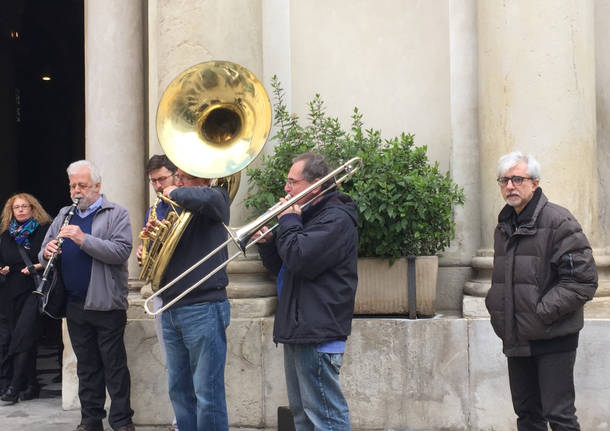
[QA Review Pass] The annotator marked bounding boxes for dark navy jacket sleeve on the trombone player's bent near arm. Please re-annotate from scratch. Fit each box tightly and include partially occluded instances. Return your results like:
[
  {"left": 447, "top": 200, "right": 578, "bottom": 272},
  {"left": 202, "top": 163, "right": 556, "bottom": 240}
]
[{"left": 276, "top": 208, "right": 355, "bottom": 279}]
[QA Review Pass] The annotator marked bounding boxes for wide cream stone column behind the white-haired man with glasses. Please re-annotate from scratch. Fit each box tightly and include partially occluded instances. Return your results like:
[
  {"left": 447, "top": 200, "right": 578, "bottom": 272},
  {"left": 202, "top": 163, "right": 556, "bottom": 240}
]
[{"left": 464, "top": 0, "right": 607, "bottom": 314}]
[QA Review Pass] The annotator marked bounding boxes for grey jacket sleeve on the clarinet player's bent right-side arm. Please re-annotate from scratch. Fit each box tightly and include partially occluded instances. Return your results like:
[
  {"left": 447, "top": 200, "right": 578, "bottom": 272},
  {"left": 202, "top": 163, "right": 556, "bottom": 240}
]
[{"left": 80, "top": 206, "right": 131, "bottom": 265}]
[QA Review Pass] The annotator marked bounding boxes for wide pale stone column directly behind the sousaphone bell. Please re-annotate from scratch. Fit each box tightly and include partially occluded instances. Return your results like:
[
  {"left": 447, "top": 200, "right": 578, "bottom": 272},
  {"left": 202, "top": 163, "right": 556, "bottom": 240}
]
[{"left": 147, "top": 0, "right": 274, "bottom": 318}]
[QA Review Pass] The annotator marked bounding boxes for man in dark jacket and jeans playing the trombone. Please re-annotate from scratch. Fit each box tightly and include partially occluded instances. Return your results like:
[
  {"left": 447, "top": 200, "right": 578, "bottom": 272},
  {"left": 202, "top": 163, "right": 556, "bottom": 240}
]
[{"left": 257, "top": 153, "right": 358, "bottom": 431}]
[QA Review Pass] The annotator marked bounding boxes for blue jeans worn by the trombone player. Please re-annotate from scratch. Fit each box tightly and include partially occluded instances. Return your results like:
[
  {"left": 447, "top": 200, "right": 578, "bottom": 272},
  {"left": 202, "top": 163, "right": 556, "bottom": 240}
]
[{"left": 284, "top": 344, "right": 351, "bottom": 431}]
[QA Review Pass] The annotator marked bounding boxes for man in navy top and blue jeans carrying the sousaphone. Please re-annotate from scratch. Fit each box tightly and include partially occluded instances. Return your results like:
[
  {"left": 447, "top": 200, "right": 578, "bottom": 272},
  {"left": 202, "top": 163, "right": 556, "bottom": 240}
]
[{"left": 150, "top": 169, "right": 230, "bottom": 431}]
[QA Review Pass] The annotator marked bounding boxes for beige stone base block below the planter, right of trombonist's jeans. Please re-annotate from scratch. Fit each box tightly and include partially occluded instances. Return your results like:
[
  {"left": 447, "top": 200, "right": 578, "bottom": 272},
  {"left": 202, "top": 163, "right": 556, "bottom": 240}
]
[{"left": 341, "top": 318, "right": 468, "bottom": 430}]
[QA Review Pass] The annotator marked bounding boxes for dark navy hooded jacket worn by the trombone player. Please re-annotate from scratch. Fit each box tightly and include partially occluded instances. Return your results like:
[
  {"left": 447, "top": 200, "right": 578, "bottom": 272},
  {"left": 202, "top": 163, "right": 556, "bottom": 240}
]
[{"left": 259, "top": 192, "right": 358, "bottom": 344}]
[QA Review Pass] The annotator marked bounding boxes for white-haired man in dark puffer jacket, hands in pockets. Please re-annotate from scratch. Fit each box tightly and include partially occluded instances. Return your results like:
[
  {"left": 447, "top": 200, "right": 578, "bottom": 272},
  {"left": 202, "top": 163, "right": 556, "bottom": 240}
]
[{"left": 486, "top": 152, "right": 597, "bottom": 431}]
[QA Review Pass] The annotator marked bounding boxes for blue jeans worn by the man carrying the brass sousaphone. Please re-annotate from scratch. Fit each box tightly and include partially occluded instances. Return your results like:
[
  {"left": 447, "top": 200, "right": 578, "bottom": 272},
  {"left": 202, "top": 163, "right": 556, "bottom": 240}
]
[{"left": 162, "top": 300, "right": 230, "bottom": 431}]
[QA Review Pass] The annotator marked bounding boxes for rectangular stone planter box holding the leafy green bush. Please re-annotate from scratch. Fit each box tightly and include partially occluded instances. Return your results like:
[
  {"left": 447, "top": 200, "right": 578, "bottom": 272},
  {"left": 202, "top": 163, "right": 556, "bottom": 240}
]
[{"left": 354, "top": 256, "right": 438, "bottom": 317}]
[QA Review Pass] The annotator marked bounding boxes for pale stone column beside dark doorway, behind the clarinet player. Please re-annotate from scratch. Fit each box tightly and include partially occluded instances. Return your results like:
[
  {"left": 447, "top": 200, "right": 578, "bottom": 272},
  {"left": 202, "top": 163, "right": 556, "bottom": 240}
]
[{"left": 85, "top": 0, "right": 146, "bottom": 277}]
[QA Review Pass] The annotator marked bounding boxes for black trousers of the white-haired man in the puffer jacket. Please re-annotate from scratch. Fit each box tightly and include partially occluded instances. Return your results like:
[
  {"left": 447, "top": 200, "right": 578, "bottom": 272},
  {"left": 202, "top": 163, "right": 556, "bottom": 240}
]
[{"left": 508, "top": 350, "right": 580, "bottom": 431}]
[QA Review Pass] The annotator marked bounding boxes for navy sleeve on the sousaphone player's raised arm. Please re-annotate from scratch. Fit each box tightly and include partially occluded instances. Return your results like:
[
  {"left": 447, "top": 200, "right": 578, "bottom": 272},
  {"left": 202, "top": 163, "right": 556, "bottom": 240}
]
[{"left": 170, "top": 187, "right": 230, "bottom": 223}]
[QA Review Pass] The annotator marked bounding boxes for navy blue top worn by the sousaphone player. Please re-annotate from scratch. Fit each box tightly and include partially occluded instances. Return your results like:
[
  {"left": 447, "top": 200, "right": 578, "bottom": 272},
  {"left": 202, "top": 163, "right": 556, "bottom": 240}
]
[{"left": 161, "top": 187, "right": 230, "bottom": 308}]
